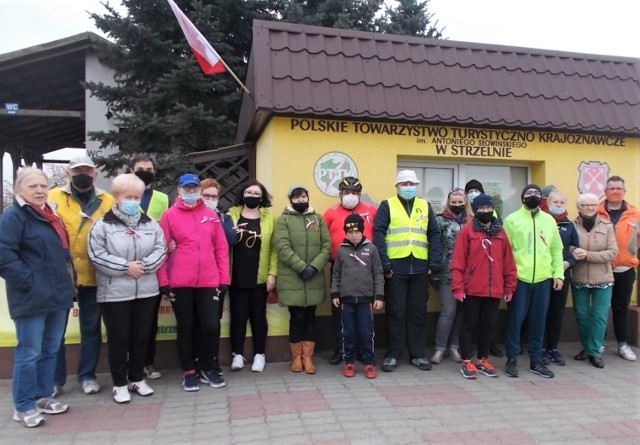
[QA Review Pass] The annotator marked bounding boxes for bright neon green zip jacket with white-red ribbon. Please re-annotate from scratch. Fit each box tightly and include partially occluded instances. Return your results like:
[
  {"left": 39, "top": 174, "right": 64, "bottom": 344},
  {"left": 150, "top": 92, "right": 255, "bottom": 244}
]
[{"left": 504, "top": 207, "right": 564, "bottom": 283}]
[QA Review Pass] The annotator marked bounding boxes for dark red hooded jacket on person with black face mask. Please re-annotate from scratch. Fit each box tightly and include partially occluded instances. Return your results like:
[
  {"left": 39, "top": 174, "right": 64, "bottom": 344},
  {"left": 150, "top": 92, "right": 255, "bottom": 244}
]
[{"left": 450, "top": 220, "right": 517, "bottom": 298}]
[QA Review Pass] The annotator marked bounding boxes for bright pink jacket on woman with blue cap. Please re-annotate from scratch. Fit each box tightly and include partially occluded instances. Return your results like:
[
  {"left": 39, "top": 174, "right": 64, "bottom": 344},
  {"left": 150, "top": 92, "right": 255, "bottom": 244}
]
[{"left": 158, "top": 198, "right": 231, "bottom": 288}]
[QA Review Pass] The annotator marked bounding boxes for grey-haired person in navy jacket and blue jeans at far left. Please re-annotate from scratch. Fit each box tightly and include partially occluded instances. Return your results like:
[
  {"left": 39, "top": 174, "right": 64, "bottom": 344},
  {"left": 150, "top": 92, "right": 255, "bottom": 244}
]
[{"left": 0, "top": 168, "right": 75, "bottom": 428}]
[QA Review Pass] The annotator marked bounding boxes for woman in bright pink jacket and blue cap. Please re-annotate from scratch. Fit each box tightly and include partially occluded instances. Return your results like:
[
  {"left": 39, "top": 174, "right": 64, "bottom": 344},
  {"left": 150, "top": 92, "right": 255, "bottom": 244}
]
[{"left": 158, "top": 173, "right": 230, "bottom": 391}]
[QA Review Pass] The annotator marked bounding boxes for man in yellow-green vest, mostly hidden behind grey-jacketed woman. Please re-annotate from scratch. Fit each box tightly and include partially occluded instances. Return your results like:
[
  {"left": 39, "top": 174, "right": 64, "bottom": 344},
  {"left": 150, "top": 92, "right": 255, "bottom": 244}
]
[{"left": 129, "top": 154, "right": 169, "bottom": 379}]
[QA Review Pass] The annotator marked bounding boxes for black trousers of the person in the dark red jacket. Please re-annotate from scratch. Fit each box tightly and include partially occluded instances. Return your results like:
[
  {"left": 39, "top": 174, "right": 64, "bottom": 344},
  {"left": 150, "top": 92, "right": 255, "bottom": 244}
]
[{"left": 460, "top": 295, "right": 500, "bottom": 360}]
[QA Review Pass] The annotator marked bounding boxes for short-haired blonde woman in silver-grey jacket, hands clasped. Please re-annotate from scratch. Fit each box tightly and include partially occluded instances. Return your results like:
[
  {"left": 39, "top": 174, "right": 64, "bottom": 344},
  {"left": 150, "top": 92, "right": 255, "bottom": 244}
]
[{"left": 88, "top": 173, "right": 166, "bottom": 403}]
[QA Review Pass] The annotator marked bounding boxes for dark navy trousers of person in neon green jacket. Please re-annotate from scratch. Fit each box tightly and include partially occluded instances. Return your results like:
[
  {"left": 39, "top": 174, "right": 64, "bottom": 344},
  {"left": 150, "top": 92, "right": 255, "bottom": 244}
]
[{"left": 504, "top": 280, "right": 552, "bottom": 363}]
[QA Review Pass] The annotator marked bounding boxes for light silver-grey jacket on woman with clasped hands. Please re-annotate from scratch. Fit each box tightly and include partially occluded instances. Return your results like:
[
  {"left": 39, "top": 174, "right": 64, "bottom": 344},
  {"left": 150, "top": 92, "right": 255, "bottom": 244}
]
[{"left": 88, "top": 210, "right": 167, "bottom": 303}]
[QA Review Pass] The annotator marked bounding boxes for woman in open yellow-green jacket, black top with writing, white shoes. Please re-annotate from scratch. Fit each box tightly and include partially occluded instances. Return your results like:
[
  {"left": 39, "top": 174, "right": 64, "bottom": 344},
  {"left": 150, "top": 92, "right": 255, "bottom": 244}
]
[{"left": 229, "top": 179, "right": 278, "bottom": 372}]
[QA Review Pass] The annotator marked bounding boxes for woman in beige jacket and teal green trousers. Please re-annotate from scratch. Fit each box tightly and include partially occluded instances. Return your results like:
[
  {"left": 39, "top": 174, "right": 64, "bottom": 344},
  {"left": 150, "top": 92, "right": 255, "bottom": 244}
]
[{"left": 571, "top": 193, "right": 618, "bottom": 368}]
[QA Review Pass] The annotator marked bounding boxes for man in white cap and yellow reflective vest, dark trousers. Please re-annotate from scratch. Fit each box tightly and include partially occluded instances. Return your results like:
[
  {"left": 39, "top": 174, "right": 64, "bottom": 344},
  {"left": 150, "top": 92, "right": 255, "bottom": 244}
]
[{"left": 373, "top": 170, "right": 442, "bottom": 372}]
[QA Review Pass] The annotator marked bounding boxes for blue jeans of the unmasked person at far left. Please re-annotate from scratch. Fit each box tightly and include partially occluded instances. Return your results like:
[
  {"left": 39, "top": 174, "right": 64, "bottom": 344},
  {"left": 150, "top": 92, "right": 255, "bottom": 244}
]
[{"left": 11, "top": 309, "right": 67, "bottom": 412}]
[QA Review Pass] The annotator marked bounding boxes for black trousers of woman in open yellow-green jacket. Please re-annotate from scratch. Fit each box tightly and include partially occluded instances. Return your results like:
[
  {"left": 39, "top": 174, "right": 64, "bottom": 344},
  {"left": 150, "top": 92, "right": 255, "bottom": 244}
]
[{"left": 229, "top": 284, "right": 268, "bottom": 355}]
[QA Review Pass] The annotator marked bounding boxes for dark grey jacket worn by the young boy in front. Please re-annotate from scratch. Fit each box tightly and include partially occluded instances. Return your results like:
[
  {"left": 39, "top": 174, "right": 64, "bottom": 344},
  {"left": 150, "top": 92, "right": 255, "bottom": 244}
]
[{"left": 331, "top": 238, "right": 384, "bottom": 303}]
